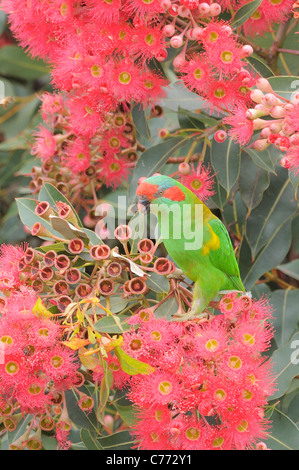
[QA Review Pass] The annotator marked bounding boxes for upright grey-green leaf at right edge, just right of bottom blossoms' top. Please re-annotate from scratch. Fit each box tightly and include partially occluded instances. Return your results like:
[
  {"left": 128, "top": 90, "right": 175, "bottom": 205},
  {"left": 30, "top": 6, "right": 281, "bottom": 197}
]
[{"left": 269, "top": 289, "right": 299, "bottom": 348}]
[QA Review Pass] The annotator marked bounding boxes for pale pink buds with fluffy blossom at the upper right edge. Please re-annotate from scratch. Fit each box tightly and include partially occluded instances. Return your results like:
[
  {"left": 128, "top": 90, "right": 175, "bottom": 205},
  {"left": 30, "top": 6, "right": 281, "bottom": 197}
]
[{"left": 224, "top": 78, "right": 299, "bottom": 174}]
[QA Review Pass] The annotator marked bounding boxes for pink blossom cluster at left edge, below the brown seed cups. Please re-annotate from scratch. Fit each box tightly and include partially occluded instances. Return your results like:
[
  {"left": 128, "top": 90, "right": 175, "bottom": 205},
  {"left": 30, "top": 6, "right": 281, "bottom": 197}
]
[{"left": 0, "top": 287, "right": 78, "bottom": 416}]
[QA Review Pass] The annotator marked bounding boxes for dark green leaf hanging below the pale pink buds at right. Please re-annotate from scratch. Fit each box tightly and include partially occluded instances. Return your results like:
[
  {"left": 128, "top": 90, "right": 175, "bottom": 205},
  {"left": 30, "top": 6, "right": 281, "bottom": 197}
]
[{"left": 239, "top": 152, "right": 270, "bottom": 213}]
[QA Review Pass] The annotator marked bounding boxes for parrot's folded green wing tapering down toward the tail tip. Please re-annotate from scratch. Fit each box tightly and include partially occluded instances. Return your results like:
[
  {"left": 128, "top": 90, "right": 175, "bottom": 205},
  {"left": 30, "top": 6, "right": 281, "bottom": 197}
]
[{"left": 209, "top": 218, "right": 245, "bottom": 291}]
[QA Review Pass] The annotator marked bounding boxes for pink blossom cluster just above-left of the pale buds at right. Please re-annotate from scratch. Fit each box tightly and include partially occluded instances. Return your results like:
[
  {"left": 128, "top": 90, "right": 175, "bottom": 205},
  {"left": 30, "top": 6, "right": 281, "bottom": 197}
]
[{"left": 177, "top": 20, "right": 256, "bottom": 111}]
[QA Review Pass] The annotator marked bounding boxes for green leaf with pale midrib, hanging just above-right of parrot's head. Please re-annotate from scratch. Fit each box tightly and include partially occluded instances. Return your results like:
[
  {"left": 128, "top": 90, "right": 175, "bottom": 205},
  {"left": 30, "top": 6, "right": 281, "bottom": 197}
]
[{"left": 211, "top": 139, "right": 241, "bottom": 197}]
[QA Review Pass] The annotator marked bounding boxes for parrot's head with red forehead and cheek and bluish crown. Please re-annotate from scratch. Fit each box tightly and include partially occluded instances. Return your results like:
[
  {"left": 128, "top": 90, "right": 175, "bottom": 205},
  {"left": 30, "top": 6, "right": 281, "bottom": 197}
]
[{"left": 136, "top": 175, "right": 186, "bottom": 212}]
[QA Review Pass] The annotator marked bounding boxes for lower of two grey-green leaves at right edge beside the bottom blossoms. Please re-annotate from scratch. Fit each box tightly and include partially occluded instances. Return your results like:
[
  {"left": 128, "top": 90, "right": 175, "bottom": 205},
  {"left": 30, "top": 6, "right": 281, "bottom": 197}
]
[{"left": 270, "top": 332, "right": 299, "bottom": 400}]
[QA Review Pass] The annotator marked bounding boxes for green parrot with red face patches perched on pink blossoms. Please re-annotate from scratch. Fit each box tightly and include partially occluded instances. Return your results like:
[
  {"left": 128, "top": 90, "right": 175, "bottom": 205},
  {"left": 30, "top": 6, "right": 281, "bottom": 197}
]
[{"left": 136, "top": 175, "right": 245, "bottom": 321}]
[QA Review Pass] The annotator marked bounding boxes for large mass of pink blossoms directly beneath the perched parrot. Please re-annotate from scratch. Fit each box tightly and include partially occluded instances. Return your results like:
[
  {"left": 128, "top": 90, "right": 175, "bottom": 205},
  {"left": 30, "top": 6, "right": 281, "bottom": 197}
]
[{"left": 123, "top": 293, "right": 275, "bottom": 450}]
